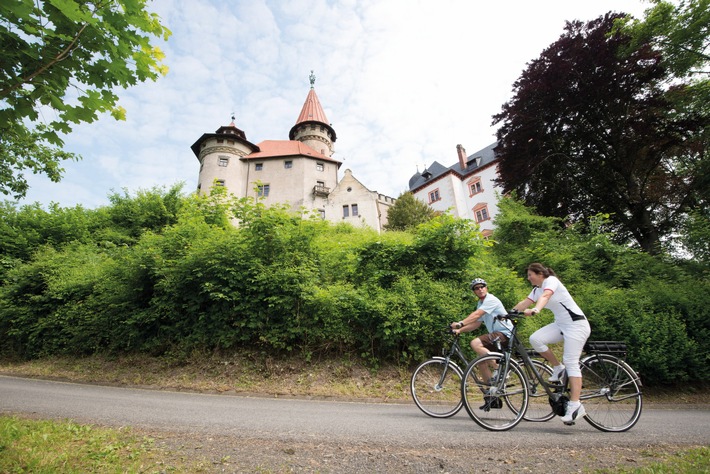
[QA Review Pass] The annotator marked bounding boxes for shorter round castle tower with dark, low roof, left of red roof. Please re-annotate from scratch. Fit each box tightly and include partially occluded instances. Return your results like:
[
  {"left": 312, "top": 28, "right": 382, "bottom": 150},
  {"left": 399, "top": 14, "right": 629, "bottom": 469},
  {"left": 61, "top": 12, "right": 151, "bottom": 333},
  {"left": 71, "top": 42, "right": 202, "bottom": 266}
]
[{"left": 190, "top": 117, "right": 259, "bottom": 196}]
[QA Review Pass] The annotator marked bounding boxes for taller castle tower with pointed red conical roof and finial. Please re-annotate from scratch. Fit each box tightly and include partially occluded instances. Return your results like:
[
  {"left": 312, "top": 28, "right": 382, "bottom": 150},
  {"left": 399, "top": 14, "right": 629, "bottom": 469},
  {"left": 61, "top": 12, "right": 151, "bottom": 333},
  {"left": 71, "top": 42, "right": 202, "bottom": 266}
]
[{"left": 288, "top": 71, "right": 336, "bottom": 158}]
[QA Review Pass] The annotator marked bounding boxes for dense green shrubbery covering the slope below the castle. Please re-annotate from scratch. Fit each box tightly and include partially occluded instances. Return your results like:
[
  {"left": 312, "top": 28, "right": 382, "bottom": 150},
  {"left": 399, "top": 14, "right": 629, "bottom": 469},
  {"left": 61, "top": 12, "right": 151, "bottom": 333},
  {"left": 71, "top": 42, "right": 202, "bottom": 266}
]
[{"left": 0, "top": 188, "right": 710, "bottom": 383}]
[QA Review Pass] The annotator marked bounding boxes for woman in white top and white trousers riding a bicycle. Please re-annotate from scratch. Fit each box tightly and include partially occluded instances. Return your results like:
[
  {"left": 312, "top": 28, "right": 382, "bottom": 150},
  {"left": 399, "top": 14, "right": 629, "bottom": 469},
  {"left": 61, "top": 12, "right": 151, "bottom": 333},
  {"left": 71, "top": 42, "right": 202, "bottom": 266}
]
[{"left": 514, "top": 263, "right": 591, "bottom": 424}]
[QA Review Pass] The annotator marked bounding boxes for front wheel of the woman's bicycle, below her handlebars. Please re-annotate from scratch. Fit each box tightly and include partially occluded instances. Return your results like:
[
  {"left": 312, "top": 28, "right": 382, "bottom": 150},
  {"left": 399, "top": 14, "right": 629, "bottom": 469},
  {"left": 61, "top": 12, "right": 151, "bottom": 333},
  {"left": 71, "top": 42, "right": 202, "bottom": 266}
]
[{"left": 461, "top": 354, "right": 528, "bottom": 431}]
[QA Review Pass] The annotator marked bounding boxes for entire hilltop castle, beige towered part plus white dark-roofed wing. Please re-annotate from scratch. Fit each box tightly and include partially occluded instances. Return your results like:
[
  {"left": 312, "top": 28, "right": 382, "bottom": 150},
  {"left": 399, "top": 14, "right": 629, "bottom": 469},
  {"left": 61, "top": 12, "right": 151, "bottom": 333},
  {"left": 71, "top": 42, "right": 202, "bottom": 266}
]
[{"left": 191, "top": 71, "right": 500, "bottom": 235}]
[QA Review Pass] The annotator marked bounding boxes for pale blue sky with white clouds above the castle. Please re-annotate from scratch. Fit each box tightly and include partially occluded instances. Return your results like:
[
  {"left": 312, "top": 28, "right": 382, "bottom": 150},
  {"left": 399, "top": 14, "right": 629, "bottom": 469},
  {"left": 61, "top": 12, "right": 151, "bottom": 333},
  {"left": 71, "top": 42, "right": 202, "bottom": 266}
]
[{"left": 13, "top": 0, "right": 650, "bottom": 209}]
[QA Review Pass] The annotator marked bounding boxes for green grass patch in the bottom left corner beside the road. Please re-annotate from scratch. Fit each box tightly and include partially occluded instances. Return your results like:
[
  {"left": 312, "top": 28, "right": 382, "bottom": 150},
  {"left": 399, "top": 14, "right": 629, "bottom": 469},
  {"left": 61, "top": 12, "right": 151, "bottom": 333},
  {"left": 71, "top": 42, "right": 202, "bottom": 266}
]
[{"left": 0, "top": 416, "right": 202, "bottom": 474}]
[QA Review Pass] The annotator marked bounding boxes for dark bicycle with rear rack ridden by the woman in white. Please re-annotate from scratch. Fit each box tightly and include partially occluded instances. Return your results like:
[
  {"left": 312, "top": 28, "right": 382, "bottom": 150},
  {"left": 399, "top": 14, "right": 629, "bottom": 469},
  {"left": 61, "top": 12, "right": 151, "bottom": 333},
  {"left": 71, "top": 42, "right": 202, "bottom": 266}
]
[{"left": 461, "top": 311, "right": 642, "bottom": 432}]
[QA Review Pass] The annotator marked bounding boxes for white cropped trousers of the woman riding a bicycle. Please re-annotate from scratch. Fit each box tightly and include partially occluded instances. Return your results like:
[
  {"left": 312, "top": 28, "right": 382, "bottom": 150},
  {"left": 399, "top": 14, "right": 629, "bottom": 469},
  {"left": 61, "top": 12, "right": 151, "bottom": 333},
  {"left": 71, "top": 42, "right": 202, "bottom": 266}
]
[{"left": 530, "top": 319, "right": 592, "bottom": 377}]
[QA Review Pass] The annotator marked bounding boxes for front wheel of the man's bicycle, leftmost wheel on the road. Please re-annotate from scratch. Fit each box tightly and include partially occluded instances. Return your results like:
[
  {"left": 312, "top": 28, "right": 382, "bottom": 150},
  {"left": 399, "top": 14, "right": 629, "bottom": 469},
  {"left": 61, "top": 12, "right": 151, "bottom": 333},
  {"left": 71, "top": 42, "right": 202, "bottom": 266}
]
[{"left": 409, "top": 358, "right": 463, "bottom": 418}]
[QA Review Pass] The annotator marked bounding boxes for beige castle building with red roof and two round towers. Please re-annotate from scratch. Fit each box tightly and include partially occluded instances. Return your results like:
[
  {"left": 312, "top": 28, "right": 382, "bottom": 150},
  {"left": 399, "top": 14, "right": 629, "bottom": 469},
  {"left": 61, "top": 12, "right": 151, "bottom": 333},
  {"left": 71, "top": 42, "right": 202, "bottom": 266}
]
[{"left": 191, "top": 71, "right": 395, "bottom": 232}]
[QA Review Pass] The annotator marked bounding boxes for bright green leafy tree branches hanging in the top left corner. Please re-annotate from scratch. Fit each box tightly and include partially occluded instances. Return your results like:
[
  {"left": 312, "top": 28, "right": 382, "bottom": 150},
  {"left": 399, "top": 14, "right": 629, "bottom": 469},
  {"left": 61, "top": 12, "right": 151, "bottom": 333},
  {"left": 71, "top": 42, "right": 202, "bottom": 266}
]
[{"left": 0, "top": 0, "right": 170, "bottom": 198}]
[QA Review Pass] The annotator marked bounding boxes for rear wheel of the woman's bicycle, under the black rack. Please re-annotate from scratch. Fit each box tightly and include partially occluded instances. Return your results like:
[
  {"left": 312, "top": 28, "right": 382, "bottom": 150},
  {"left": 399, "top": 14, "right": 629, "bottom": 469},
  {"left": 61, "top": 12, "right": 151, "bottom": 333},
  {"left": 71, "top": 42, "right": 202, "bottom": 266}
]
[{"left": 580, "top": 354, "right": 642, "bottom": 431}]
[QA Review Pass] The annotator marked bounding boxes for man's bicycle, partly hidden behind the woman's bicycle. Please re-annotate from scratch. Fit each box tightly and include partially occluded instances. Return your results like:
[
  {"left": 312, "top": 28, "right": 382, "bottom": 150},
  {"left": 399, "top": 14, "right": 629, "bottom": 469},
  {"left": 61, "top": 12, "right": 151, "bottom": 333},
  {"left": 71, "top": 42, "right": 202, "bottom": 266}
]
[{"left": 409, "top": 328, "right": 555, "bottom": 421}]
